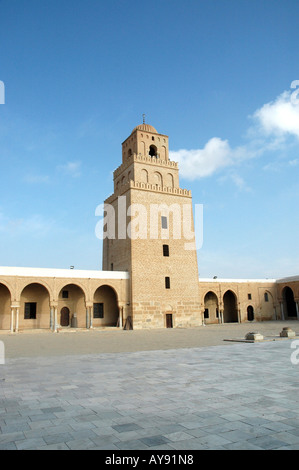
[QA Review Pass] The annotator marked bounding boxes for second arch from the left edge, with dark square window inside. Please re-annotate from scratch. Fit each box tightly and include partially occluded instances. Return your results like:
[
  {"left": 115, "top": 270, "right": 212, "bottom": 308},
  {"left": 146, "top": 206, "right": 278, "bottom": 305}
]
[{"left": 19, "top": 281, "right": 50, "bottom": 329}]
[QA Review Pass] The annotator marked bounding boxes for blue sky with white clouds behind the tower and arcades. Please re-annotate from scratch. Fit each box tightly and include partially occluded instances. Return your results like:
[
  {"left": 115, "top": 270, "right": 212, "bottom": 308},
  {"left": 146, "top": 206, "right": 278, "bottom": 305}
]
[{"left": 0, "top": 0, "right": 299, "bottom": 278}]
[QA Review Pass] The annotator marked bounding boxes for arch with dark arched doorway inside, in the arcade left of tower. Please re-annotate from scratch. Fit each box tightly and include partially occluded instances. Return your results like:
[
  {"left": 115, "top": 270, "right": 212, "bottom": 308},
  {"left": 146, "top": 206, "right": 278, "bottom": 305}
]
[{"left": 58, "top": 283, "right": 86, "bottom": 328}]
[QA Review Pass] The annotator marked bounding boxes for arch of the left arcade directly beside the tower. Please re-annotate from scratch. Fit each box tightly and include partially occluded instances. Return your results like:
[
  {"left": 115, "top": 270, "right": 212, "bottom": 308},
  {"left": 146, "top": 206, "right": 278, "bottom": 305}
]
[{"left": 92, "top": 284, "right": 119, "bottom": 327}]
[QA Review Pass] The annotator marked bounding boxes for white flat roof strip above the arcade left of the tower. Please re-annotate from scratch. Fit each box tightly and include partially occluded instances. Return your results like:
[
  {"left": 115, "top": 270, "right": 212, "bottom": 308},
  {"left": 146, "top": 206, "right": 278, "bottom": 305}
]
[{"left": 0, "top": 266, "right": 130, "bottom": 279}]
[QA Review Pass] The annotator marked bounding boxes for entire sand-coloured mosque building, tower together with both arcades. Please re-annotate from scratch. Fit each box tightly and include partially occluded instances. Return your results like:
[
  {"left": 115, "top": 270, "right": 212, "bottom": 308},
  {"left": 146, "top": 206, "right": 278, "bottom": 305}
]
[{"left": 0, "top": 123, "right": 299, "bottom": 333}]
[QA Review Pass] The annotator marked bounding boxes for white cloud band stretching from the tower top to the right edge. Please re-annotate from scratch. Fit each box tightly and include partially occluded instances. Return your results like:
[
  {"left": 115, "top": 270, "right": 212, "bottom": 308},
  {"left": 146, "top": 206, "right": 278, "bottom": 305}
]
[{"left": 170, "top": 85, "right": 299, "bottom": 185}]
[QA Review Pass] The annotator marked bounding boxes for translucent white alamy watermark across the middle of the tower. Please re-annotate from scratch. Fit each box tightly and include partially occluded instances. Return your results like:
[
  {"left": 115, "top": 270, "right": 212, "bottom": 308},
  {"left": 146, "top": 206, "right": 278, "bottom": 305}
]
[{"left": 95, "top": 196, "right": 203, "bottom": 250}]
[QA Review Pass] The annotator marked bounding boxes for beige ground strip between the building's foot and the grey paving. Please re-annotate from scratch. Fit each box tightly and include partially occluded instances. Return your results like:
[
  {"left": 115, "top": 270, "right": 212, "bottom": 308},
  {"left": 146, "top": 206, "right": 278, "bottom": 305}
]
[{"left": 0, "top": 320, "right": 299, "bottom": 358}]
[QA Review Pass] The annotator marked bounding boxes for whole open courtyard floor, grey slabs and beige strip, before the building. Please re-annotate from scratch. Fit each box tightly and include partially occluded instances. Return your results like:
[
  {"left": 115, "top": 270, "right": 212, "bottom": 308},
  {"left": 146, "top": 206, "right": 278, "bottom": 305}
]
[{"left": 0, "top": 322, "right": 299, "bottom": 451}]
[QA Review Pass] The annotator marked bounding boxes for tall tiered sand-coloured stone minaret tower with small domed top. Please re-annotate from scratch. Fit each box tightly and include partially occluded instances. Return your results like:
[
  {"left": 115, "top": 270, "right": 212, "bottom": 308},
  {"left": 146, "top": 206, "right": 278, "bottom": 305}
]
[{"left": 103, "top": 123, "right": 202, "bottom": 329}]
